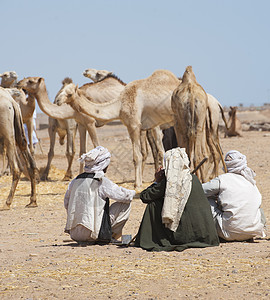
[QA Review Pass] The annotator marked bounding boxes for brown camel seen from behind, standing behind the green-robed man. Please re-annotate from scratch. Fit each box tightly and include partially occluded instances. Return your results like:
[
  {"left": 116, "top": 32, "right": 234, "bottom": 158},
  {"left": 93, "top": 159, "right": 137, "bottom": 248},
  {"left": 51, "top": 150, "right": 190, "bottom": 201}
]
[{"left": 171, "top": 66, "right": 225, "bottom": 182}]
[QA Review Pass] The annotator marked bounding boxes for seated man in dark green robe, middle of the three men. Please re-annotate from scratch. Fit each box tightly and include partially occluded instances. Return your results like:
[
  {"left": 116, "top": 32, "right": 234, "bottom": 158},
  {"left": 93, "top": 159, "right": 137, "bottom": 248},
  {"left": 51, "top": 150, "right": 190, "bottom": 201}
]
[{"left": 134, "top": 147, "right": 219, "bottom": 251}]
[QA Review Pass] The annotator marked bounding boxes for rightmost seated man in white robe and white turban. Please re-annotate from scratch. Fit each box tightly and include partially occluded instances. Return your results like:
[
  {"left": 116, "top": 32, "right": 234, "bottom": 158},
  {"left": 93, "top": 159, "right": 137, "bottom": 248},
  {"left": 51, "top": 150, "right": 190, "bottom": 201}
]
[{"left": 202, "top": 150, "right": 265, "bottom": 241}]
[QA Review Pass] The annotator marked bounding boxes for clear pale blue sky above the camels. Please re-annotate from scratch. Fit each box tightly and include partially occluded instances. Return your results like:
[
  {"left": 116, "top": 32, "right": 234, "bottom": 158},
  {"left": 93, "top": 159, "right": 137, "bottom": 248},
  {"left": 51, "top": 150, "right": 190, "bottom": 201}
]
[{"left": 0, "top": 0, "right": 270, "bottom": 112}]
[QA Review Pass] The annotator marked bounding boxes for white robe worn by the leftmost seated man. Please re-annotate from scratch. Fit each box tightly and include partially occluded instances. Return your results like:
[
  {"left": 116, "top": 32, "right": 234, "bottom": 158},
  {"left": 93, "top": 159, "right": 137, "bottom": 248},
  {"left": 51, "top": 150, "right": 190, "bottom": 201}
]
[{"left": 64, "top": 173, "right": 135, "bottom": 241}]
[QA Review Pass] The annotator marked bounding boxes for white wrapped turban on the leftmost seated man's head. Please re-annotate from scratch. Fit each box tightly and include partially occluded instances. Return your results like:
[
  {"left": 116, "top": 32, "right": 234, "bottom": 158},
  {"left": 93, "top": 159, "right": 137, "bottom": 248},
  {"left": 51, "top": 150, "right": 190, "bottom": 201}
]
[{"left": 79, "top": 146, "right": 111, "bottom": 178}]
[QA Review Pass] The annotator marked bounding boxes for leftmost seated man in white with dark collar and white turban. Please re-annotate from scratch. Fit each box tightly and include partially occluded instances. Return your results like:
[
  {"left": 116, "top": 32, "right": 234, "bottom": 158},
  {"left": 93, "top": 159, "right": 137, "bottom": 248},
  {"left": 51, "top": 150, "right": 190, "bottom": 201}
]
[{"left": 64, "top": 146, "right": 135, "bottom": 243}]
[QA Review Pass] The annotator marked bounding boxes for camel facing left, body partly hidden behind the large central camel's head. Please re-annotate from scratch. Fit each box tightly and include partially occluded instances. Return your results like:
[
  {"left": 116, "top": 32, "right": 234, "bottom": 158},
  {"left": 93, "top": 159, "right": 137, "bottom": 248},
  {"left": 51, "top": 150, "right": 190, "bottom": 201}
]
[{"left": 19, "top": 75, "right": 130, "bottom": 180}]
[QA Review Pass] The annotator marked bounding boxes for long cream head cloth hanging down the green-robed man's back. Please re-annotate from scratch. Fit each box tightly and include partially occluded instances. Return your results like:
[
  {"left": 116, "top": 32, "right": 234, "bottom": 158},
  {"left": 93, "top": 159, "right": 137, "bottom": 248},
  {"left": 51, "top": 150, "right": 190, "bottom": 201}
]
[{"left": 161, "top": 147, "right": 192, "bottom": 231}]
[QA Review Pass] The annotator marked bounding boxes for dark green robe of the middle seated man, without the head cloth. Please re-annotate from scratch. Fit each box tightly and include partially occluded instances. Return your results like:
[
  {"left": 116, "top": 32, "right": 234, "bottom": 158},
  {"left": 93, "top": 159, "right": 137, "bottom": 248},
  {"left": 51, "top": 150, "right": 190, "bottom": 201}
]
[{"left": 135, "top": 175, "right": 219, "bottom": 251}]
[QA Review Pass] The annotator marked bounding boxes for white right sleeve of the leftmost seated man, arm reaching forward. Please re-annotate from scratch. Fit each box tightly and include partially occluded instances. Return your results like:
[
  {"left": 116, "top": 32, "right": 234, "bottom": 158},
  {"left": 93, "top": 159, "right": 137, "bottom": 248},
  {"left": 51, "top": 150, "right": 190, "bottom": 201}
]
[{"left": 98, "top": 177, "right": 136, "bottom": 202}]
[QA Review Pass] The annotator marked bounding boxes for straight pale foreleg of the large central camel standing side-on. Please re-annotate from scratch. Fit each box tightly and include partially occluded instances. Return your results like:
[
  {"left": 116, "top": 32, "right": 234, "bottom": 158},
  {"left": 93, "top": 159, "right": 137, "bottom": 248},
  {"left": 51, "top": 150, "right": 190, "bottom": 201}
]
[{"left": 127, "top": 125, "right": 142, "bottom": 188}]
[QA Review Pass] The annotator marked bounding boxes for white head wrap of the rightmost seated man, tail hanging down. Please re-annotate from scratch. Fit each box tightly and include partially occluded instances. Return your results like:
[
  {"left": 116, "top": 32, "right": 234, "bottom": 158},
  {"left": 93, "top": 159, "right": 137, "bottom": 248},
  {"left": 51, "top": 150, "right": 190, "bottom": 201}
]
[{"left": 225, "top": 150, "right": 256, "bottom": 185}]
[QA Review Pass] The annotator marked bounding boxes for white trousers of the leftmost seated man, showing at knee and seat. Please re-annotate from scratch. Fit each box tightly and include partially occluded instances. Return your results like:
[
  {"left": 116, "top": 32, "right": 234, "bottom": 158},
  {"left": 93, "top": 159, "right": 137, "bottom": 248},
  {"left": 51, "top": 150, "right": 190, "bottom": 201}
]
[{"left": 70, "top": 202, "right": 131, "bottom": 242}]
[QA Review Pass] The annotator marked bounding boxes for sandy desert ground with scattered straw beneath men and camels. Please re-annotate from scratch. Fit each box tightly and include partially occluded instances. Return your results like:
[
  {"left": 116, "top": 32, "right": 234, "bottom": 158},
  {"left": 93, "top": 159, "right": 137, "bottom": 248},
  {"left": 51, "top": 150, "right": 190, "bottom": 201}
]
[{"left": 0, "top": 114, "right": 270, "bottom": 299}]
